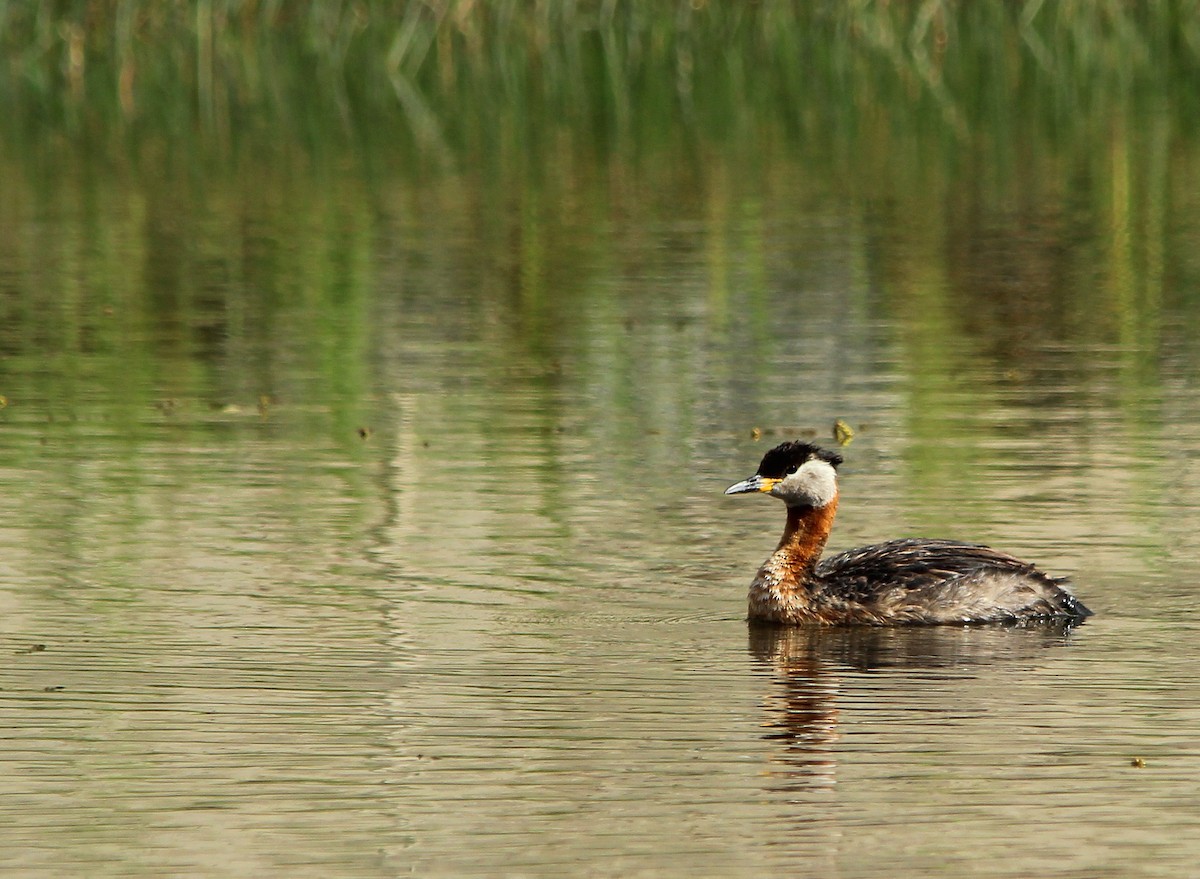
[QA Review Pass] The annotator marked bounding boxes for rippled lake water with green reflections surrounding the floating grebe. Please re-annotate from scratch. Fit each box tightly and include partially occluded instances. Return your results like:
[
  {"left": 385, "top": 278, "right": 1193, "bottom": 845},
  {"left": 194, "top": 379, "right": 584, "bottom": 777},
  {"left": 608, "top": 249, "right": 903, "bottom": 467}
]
[{"left": 0, "top": 15, "right": 1200, "bottom": 879}]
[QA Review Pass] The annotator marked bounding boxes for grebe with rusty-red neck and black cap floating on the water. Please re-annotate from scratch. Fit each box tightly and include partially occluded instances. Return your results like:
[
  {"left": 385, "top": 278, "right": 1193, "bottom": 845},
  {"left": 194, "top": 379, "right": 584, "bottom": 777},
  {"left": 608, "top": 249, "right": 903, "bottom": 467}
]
[{"left": 725, "top": 442, "right": 1091, "bottom": 626}]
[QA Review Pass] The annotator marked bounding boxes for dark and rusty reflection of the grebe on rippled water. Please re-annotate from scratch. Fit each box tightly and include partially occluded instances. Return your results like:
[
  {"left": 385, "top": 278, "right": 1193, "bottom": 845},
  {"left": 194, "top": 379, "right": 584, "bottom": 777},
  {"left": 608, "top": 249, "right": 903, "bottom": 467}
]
[{"left": 750, "top": 622, "right": 1072, "bottom": 790}]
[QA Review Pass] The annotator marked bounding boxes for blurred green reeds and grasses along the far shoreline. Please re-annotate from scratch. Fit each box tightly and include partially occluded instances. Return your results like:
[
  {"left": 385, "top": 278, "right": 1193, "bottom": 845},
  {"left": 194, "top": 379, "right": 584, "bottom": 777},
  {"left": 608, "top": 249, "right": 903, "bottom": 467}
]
[{"left": 0, "top": 0, "right": 1200, "bottom": 168}]
